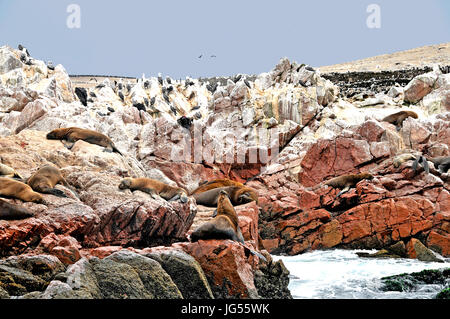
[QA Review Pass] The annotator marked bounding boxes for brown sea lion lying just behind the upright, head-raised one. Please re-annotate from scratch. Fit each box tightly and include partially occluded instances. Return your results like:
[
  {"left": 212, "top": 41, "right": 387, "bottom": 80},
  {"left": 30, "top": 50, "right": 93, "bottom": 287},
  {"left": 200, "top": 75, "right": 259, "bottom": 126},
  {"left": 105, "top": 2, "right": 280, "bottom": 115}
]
[{"left": 192, "top": 185, "right": 258, "bottom": 207}]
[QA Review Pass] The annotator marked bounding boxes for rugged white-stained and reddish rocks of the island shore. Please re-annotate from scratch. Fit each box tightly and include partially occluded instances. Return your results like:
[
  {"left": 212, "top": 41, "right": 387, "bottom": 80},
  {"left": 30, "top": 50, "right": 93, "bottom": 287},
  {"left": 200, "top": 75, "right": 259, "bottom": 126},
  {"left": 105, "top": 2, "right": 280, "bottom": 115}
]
[{"left": 0, "top": 43, "right": 450, "bottom": 299}]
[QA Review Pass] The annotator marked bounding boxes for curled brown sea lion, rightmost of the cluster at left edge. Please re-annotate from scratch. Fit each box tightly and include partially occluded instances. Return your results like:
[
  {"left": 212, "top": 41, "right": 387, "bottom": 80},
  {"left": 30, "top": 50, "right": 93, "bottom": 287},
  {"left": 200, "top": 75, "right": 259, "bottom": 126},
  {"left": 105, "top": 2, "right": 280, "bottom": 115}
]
[{"left": 27, "top": 165, "right": 78, "bottom": 197}]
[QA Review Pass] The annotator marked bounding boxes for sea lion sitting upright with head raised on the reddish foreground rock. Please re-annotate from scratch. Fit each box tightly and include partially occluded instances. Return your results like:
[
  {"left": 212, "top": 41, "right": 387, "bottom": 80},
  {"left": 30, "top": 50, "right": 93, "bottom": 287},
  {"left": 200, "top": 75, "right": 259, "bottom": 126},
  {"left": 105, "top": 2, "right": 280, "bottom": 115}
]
[{"left": 191, "top": 190, "right": 266, "bottom": 260}]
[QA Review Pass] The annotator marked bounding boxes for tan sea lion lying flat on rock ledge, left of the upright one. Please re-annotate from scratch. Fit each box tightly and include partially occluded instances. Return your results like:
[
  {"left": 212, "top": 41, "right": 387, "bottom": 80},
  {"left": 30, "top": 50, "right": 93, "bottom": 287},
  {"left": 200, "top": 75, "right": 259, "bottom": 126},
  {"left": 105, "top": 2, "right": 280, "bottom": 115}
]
[{"left": 119, "top": 177, "right": 188, "bottom": 203}]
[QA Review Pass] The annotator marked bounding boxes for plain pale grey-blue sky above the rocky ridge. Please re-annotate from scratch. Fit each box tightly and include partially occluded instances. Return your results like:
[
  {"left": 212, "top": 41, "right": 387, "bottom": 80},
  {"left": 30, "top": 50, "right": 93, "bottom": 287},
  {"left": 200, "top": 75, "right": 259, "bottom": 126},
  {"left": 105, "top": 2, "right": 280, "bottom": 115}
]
[{"left": 0, "top": 0, "right": 450, "bottom": 79}]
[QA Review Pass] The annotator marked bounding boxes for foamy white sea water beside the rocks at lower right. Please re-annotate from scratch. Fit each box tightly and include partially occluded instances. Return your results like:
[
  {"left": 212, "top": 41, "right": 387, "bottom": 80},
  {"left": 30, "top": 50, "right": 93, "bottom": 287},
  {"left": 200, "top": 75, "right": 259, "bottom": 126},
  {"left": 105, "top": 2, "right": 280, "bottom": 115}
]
[{"left": 273, "top": 249, "right": 450, "bottom": 299}]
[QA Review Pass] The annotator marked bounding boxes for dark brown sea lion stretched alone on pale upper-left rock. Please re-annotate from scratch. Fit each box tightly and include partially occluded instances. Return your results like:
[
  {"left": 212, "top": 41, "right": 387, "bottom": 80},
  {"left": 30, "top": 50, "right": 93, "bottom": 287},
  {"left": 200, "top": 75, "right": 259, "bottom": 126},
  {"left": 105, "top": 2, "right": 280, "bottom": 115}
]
[{"left": 47, "top": 127, "right": 122, "bottom": 155}]
